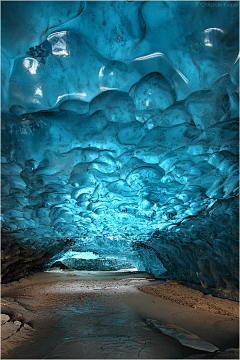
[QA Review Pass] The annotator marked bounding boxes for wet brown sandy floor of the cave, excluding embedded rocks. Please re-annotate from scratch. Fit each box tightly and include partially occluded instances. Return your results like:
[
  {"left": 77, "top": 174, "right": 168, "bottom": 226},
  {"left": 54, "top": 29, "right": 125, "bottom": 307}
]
[{"left": 1, "top": 271, "right": 239, "bottom": 359}]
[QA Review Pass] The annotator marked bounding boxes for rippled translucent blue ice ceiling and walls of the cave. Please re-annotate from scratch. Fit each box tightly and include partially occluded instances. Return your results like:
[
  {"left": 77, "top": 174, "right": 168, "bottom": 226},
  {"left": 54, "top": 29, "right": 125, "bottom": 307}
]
[{"left": 1, "top": 1, "right": 239, "bottom": 288}]
